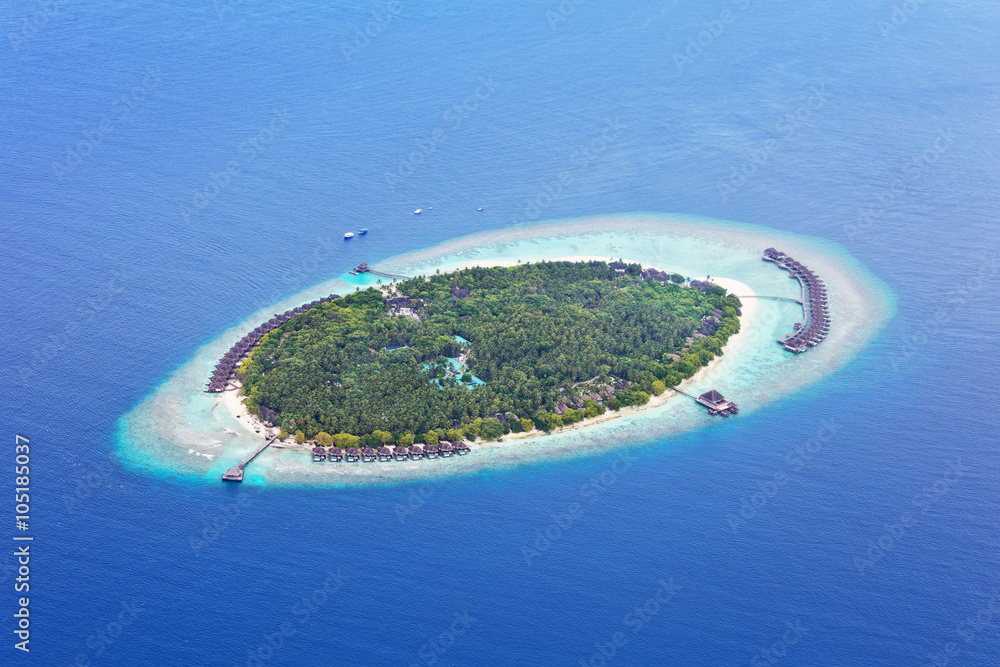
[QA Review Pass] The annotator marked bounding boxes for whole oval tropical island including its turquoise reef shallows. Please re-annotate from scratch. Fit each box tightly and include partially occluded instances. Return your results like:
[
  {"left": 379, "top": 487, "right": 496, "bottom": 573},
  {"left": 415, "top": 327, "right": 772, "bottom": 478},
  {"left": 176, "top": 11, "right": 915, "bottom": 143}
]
[{"left": 116, "top": 213, "right": 894, "bottom": 488}]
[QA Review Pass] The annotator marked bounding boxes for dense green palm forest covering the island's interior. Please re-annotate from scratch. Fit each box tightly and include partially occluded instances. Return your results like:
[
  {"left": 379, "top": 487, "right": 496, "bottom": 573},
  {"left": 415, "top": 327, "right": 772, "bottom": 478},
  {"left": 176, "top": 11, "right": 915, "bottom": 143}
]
[{"left": 239, "top": 261, "right": 740, "bottom": 445}]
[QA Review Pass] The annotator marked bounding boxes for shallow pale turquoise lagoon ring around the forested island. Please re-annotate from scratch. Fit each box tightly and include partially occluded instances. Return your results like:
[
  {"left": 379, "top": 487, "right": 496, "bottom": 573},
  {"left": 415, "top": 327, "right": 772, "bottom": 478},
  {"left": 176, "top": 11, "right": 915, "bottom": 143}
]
[{"left": 118, "top": 213, "right": 894, "bottom": 486}]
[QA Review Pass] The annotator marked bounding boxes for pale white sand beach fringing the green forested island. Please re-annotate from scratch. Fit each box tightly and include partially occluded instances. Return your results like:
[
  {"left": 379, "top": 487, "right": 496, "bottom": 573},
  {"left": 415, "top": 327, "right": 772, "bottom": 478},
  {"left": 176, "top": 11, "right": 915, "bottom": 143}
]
[{"left": 219, "top": 264, "right": 757, "bottom": 456}]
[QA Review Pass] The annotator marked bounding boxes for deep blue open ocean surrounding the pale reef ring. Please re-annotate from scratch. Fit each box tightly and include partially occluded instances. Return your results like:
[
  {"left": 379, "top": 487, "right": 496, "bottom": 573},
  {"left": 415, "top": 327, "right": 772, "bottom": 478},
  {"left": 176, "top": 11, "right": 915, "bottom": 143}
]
[{"left": 0, "top": 0, "right": 1000, "bottom": 667}]
